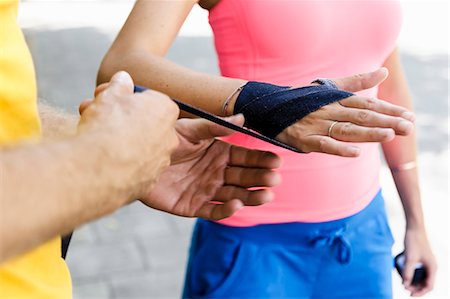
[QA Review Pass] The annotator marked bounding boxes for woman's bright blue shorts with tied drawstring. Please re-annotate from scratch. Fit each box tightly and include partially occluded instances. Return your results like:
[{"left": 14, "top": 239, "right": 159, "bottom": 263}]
[{"left": 183, "top": 191, "right": 394, "bottom": 299}]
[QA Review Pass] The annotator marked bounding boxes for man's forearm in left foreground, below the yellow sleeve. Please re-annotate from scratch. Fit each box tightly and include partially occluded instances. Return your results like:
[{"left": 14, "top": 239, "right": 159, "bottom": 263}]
[{"left": 0, "top": 134, "right": 139, "bottom": 262}]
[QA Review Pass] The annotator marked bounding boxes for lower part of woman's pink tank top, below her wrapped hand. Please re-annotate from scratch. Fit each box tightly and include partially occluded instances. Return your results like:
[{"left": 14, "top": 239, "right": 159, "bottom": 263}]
[{"left": 216, "top": 139, "right": 380, "bottom": 226}]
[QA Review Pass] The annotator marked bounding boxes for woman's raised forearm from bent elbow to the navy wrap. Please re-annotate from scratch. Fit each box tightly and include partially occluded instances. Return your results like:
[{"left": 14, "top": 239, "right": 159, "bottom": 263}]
[{"left": 97, "top": 48, "right": 246, "bottom": 115}]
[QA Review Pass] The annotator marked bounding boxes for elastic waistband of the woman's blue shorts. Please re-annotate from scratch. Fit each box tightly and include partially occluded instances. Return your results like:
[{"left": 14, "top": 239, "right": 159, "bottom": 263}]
[{"left": 196, "top": 190, "right": 384, "bottom": 243}]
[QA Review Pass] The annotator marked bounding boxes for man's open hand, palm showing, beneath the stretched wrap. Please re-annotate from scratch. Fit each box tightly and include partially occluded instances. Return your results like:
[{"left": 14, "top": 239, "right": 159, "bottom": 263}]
[{"left": 141, "top": 115, "right": 281, "bottom": 220}]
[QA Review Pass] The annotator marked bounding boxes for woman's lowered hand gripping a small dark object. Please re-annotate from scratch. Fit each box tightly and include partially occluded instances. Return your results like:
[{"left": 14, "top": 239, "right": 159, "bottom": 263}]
[{"left": 402, "top": 228, "right": 437, "bottom": 297}]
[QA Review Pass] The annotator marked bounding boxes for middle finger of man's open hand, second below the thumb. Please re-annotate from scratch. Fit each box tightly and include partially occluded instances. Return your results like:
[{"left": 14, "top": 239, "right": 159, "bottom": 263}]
[{"left": 225, "top": 167, "right": 281, "bottom": 188}]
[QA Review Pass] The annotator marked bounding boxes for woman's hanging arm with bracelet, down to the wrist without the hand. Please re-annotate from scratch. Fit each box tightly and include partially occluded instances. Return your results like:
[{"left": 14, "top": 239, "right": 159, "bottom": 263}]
[{"left": 378, "top": 51, "right": 423, "bottom": 228}]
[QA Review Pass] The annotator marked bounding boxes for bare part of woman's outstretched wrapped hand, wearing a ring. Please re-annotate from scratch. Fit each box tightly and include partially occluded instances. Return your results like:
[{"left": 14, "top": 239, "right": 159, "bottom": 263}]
[{"left": 277, "top": 68, "right": 414, "bottom": 157}]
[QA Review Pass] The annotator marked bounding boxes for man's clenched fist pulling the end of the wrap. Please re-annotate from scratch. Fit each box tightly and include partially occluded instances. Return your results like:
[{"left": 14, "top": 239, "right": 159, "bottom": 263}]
[{"left": 78, "top": 72, "right": 179, "bottom": 204}]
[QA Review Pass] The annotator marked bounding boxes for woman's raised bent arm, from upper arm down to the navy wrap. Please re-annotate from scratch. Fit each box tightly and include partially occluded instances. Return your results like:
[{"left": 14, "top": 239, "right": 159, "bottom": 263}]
[{"left": 97, "top": 0, "right": 246, "bottom": 115}]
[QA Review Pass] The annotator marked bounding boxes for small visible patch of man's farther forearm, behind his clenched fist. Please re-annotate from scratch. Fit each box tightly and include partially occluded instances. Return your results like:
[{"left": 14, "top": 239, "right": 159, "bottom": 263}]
[{"left": 38, "top": 100, "right": 79, "bottom": 140}]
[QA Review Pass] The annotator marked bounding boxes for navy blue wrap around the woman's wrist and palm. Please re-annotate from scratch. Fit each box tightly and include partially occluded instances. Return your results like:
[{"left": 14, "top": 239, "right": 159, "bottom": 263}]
[{"left": 234, "top": 79, "right": 353, "bottom": 138}]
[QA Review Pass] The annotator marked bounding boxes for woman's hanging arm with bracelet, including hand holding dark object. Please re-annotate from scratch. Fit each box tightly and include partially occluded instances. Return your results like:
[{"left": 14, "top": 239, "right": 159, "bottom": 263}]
[{"left": 378, "top": 50, "right": 436, "bottom": 295}]
